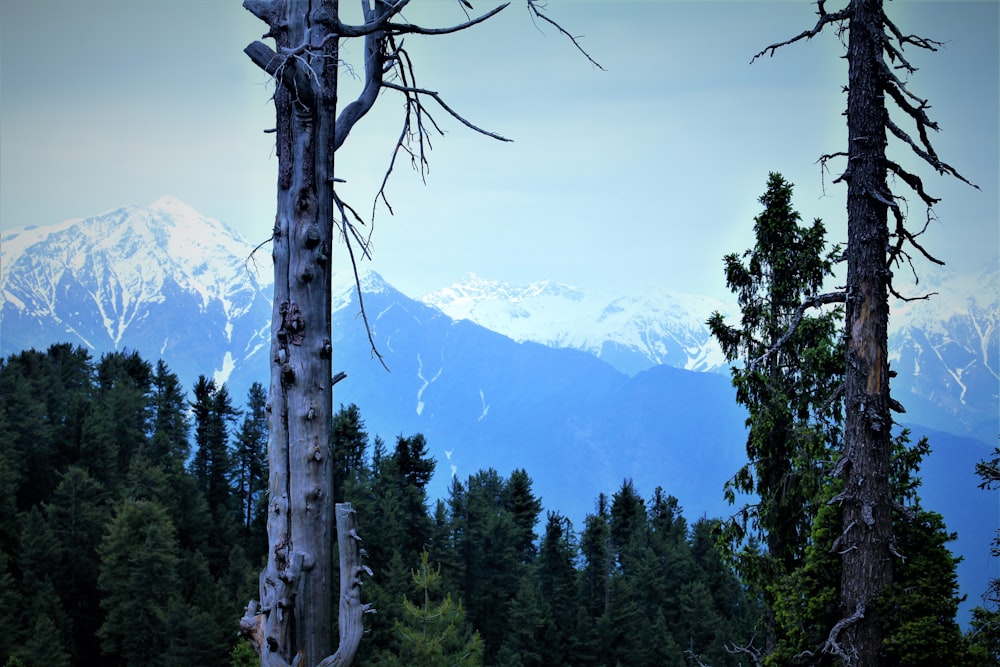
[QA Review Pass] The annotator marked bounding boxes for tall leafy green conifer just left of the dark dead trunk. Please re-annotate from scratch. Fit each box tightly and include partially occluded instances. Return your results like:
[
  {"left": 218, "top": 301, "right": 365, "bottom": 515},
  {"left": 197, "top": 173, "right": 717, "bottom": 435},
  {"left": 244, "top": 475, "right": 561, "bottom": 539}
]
[{"left": 708, "top": 173, "right": 844, "bottom": 652}]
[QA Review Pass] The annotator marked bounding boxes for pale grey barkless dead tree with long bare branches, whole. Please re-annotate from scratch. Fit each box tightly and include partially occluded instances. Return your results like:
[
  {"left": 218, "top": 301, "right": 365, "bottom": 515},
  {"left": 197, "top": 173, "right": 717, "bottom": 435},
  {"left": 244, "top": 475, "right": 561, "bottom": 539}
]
[{"left": 240, "top": 0, "right": 596, "bottom": 667}]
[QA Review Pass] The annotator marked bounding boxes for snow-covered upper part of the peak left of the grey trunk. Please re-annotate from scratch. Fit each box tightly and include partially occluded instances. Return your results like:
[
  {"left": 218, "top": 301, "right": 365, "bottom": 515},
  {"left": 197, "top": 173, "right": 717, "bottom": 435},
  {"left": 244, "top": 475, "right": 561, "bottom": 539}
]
[{"left": 0, "top": 196, "right": 270, "bottom": 336}]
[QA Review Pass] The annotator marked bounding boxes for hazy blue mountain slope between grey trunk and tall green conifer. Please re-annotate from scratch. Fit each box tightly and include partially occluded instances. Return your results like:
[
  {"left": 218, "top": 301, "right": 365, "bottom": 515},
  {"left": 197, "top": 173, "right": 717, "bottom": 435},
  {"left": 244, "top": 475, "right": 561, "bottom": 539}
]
[{"left": 334, "top": 286, "right": 745, "bottom": 524}]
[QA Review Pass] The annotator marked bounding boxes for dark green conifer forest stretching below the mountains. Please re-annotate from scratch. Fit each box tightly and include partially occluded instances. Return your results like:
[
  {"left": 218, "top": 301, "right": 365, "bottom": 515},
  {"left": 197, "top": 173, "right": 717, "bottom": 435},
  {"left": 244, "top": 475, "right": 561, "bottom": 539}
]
[{"left": 0, "top": 345, "right": 992, "bottom": 667}]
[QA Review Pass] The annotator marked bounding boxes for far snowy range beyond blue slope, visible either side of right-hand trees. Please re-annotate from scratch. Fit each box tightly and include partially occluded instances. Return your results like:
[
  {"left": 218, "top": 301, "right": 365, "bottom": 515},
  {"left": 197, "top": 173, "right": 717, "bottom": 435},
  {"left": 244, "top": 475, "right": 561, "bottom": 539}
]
[{"left": 423, "top": 266, "right": 1000, "bottom": 442}]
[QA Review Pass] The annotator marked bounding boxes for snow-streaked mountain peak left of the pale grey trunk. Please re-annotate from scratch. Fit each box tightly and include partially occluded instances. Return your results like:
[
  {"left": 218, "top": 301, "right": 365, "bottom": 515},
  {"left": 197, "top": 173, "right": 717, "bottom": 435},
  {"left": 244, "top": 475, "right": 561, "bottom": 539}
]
[{"left": 0, "top": 197, "right": 271, "bottom": 394}]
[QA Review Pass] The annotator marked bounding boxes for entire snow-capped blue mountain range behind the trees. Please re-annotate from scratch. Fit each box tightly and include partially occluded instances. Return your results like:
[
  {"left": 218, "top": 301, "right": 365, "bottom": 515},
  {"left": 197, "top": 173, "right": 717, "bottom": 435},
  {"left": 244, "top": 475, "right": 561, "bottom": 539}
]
[{"left": 0, "top": 197, "right": 1000, "bottom": 624}]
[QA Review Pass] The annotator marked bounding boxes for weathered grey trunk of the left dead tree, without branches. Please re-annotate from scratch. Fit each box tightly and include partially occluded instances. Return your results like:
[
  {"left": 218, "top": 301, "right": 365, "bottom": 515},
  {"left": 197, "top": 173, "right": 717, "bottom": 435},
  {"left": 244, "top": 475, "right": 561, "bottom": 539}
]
[{"left": 244, "top": 0, "right": 363, "bottom": 667}]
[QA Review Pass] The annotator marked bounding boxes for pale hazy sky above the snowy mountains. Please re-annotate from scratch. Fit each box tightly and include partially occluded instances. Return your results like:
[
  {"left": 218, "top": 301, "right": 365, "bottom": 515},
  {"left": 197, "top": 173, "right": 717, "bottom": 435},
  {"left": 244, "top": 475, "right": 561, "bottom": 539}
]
[{"left": 0, "top": 0, "right": 1000, "bottom": 296}]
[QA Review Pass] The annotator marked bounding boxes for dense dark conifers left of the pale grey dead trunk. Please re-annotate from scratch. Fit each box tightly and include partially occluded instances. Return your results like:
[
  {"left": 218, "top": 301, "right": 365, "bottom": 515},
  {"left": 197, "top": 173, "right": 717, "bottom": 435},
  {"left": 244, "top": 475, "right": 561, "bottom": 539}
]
[{"left": 0, "top": 345, "right": 264, "bottom": 667}]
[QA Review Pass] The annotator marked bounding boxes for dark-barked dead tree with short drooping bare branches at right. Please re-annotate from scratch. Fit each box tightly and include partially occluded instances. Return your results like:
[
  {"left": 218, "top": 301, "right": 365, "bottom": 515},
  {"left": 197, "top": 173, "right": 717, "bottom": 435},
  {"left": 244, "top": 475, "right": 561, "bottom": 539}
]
[{"left": 754, "top": 0, "right": 968, "bottom": 667}]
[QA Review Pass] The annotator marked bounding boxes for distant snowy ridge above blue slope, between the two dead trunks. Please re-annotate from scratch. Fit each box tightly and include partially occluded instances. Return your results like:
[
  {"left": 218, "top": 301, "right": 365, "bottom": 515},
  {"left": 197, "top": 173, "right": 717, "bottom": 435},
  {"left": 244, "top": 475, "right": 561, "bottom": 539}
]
[{"left": 422, "top": 274, "right": 734, "bottom": 374}]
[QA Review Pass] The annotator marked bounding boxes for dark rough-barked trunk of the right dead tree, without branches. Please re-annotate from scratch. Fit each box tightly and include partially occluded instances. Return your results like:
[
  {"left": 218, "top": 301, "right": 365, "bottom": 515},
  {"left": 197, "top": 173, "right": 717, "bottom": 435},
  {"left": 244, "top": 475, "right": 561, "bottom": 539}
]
[{"left": 839, "top": 0, "right": 892, "bottom": 667}]
